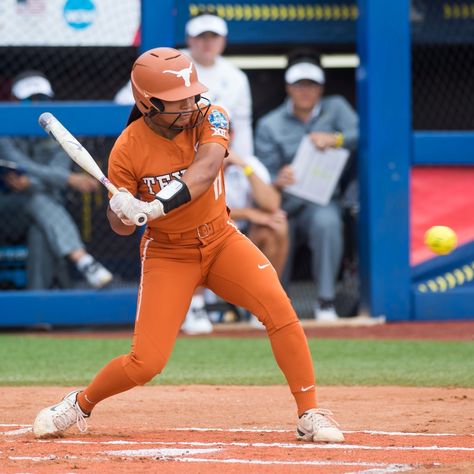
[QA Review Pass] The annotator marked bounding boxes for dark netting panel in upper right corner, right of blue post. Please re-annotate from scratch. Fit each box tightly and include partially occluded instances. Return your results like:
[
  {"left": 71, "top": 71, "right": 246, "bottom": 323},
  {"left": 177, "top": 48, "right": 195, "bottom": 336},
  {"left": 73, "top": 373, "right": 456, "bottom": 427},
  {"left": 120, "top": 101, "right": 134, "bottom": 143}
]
[{"left": 411, "top": 0, "right": 474, "bottom": 130}]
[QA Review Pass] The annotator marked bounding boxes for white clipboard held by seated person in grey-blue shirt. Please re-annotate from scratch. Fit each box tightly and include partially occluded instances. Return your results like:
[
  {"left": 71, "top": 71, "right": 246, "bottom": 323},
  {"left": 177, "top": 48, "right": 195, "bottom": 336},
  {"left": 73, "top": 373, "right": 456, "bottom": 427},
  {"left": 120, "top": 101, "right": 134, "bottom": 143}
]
[{"left": 285, "top": 135, "right": 349, "bottom": 206}]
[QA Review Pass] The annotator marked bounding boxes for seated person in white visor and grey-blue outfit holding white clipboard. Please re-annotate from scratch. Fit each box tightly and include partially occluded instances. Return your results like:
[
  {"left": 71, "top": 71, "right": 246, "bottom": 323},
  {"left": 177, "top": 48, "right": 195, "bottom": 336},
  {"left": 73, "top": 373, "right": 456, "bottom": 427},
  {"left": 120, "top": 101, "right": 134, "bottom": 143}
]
[{"left": 255, "top": 51, "right": 359, "bottom": 321}]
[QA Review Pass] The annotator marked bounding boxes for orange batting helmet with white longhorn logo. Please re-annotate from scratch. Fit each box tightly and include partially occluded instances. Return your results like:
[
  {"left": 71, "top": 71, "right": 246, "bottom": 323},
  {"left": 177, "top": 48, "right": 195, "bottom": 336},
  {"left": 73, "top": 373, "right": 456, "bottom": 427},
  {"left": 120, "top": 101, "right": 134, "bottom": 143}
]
[{"left": 131, "top": 48, "right": 208, "bottom": 115}]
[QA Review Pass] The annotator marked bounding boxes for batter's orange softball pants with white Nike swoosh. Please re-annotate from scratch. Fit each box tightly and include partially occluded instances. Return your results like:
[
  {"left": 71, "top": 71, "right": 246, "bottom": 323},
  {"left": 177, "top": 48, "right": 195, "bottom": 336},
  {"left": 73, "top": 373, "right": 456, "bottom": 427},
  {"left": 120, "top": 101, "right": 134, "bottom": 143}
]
[{"left": 78, "top": 220, "right": 316, "bottom": 414}]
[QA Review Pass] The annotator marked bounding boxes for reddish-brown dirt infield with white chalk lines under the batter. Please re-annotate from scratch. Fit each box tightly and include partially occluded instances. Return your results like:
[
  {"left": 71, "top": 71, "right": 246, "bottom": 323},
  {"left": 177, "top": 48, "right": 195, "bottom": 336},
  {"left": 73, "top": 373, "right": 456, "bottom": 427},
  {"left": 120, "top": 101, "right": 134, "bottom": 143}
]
[{"left": 0, "top": 322, "right": 474, "bottom": 474}]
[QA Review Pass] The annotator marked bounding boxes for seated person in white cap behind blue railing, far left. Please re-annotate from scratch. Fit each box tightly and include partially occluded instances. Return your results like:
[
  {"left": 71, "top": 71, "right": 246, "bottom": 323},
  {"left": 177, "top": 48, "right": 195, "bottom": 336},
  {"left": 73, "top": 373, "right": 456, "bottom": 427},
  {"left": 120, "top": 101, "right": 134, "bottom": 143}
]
[{"left": 0, "top": 71, "right": 112, "bottom": 289}]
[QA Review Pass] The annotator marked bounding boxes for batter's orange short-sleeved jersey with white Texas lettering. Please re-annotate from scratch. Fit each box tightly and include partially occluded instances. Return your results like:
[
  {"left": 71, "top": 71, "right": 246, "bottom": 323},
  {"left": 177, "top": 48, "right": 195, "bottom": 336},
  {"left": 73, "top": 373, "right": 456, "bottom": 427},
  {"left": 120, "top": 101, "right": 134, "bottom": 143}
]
[{"left": 108, "top": 106, "right": 229, "bottom": 233}]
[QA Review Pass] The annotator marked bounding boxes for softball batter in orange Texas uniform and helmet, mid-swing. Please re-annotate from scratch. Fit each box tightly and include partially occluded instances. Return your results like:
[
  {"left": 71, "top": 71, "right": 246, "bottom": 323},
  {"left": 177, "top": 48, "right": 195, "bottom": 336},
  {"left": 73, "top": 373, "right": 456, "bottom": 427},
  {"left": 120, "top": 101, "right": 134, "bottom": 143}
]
[{"left": 33, "top": 48, "right": 344, "bottom": 442}]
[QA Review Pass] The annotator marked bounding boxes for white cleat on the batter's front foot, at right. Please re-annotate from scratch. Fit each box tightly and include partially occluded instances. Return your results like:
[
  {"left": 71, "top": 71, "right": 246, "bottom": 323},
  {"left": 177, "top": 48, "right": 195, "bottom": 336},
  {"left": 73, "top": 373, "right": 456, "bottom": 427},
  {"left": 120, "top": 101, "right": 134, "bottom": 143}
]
[{"left": 296, "top": 408, "right": 344, "bottom": 443}]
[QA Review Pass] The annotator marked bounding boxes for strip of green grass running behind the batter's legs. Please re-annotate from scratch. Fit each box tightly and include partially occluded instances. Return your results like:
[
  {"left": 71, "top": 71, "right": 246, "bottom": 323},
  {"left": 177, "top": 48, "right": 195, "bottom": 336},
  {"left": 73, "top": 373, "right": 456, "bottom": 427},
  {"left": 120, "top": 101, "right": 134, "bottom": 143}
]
[{"left": 0, "top": 335, "right": 474, "bottom": 387}]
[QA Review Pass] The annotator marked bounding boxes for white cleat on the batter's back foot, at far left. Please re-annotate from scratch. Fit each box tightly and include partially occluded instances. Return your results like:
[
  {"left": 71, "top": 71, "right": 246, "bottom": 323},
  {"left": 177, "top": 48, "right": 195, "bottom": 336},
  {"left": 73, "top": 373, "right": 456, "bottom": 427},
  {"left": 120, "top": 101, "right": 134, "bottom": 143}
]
[{"left": 33, "top": 390, "right": 89, "bottom": 438}]
